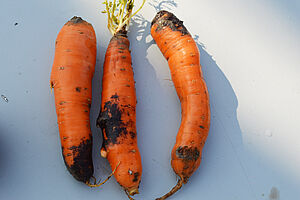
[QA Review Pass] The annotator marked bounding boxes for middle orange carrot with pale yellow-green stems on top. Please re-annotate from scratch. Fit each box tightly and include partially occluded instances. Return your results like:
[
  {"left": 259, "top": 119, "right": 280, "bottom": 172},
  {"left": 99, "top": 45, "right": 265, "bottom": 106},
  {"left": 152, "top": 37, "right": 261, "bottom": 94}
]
[{"left": 97, "top": 0, "right": 145, "bottom": 195}]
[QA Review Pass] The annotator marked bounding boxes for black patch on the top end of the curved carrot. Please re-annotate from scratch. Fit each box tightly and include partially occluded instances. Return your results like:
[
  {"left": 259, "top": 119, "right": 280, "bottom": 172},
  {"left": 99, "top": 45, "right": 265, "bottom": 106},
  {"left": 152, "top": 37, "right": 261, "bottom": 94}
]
[{"left": 151, "top": 10, "right": 190, "bottom": 35}]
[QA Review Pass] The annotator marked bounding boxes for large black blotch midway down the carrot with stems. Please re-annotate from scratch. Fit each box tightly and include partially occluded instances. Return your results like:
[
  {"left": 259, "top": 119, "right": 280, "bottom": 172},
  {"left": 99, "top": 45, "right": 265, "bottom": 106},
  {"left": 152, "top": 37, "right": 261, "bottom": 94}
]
[{"left": 97, "top": 101, "right": 127, "bottom": 146}]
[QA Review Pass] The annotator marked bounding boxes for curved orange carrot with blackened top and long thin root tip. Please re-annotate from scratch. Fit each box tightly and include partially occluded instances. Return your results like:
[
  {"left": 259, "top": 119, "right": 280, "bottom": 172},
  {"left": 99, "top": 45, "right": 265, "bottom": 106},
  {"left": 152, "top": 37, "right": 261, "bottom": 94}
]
[{"left": 151, "top": 10, "right": 210, "bottom": 200}]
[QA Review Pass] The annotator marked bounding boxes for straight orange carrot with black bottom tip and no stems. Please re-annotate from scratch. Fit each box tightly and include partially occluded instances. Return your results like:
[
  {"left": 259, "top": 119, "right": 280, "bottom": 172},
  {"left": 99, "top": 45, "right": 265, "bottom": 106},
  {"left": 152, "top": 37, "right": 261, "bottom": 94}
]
[{"left": 50, "top": 16, "right": 96, "bottom": 182}]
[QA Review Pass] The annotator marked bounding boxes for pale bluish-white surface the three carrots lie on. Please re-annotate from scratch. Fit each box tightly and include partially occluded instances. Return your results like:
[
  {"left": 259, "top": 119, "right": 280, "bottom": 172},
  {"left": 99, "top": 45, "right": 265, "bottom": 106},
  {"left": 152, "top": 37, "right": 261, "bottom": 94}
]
[{"left": 0, "top": 0, "right": 300, "bottom": 200}]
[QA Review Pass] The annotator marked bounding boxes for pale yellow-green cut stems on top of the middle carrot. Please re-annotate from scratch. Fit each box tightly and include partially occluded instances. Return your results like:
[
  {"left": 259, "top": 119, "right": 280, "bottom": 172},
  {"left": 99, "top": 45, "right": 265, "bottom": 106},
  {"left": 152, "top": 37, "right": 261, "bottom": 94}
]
[{"left": 102, "top": 0, "right": 146, "bottom": 35}]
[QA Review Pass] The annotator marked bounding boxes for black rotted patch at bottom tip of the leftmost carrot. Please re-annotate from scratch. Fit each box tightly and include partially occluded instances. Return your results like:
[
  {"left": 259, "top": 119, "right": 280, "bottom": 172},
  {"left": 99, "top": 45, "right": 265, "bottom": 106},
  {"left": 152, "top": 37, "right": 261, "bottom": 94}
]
[{"left": 62, "top": 139, "right": 94, "bottom": 183}]
